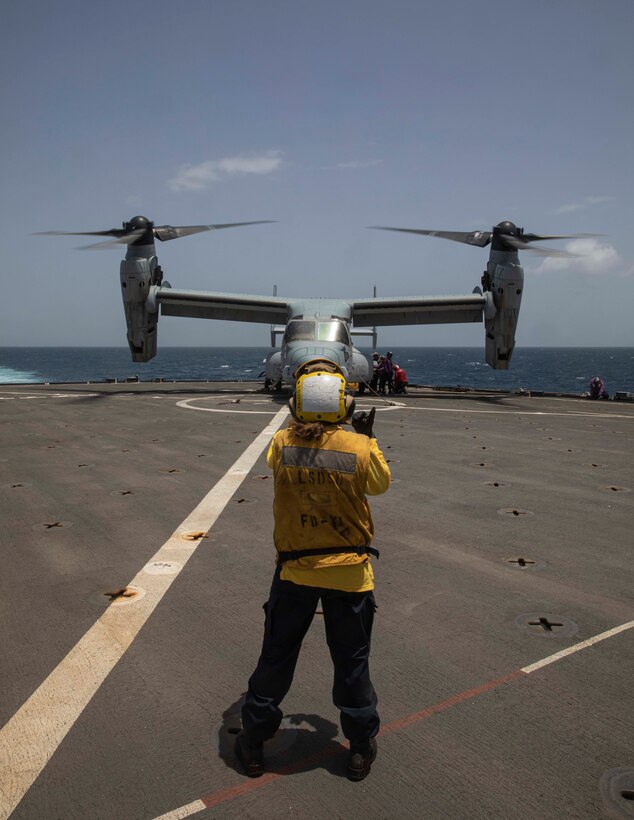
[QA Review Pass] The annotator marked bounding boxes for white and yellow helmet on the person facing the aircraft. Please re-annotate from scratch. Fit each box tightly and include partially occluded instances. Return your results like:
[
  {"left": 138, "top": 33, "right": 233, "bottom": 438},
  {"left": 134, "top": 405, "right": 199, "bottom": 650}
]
[{"left": 290, "top": 360, "right": 354, "bottom": 424}]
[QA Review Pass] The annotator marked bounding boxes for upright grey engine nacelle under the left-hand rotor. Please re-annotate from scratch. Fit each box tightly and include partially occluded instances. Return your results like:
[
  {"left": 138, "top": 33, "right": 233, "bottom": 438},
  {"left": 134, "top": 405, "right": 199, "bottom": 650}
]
[{"left": 121, "top": 256, "right": 160, "bottom": 362}]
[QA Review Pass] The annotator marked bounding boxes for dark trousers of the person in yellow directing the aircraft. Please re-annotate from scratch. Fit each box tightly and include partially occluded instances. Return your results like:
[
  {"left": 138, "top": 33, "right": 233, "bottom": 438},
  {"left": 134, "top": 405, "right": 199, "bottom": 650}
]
[{"left": 242, "top": 566, "right": 380, "bottom": 742}]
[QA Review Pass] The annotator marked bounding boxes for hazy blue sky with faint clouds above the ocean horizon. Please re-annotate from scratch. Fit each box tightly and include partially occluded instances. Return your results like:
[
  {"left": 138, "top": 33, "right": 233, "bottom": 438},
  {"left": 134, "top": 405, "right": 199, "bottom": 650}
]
[{"left": 0, "top": 0, "right": 634, "bottom": 347}]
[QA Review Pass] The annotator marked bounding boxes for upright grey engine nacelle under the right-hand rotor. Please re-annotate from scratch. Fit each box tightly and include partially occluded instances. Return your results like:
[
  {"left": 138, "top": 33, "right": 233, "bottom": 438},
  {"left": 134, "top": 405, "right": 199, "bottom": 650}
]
[{"left": 483, "top": 251, "right": 524, "bottom": 370}]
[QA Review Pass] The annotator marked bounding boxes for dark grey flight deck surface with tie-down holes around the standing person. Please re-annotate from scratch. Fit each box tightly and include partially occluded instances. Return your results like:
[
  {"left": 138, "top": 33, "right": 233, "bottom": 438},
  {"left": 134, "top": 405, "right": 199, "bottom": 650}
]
[{"left": 0, "top": 383, "right": 634, "bottom": 820}]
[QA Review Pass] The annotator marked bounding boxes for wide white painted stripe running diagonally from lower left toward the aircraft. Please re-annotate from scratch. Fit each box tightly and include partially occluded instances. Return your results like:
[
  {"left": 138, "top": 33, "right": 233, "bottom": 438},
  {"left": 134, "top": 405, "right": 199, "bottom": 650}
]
[{"left": 0, "top": 407, "right": 288, "bottom": 819}]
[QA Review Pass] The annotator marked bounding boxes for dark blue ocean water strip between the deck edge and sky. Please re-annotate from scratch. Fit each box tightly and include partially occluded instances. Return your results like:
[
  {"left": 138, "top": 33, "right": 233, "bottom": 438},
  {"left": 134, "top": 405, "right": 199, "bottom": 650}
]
[{"left": 0, "top": 347, "right": 634, "bottom": 394}]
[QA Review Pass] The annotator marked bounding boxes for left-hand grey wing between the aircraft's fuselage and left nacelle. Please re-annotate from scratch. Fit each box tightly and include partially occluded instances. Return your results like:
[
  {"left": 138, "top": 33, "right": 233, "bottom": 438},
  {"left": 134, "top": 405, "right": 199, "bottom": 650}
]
[{"left": 156, "top": 287, "right": 288, "bottom": 324}]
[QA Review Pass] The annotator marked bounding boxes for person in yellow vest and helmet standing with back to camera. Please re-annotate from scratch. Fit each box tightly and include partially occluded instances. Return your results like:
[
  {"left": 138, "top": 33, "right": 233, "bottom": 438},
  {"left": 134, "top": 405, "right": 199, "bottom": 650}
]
[{"left": 235, "top": 360, "right": 390, "bottom": 781}]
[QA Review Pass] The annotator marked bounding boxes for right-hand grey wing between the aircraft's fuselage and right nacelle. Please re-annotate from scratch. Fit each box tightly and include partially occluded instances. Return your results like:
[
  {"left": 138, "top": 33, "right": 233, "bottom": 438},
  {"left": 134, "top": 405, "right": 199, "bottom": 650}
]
[{"left": 351, "top": 292, "right": 486, "bottom": 327}]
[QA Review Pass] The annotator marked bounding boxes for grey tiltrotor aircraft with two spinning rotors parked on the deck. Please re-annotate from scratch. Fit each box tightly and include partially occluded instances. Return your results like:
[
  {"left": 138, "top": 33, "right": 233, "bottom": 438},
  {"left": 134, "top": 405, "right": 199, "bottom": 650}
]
[{"left": 38, "top": 216, "right": 594, "bottom": 388}]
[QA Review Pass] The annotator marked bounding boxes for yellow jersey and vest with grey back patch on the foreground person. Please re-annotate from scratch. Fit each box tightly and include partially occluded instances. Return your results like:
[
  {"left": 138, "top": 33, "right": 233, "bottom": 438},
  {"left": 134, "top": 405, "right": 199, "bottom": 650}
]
[{"left": 267, "top": 424, "right": 390, "bottom": 592}]
